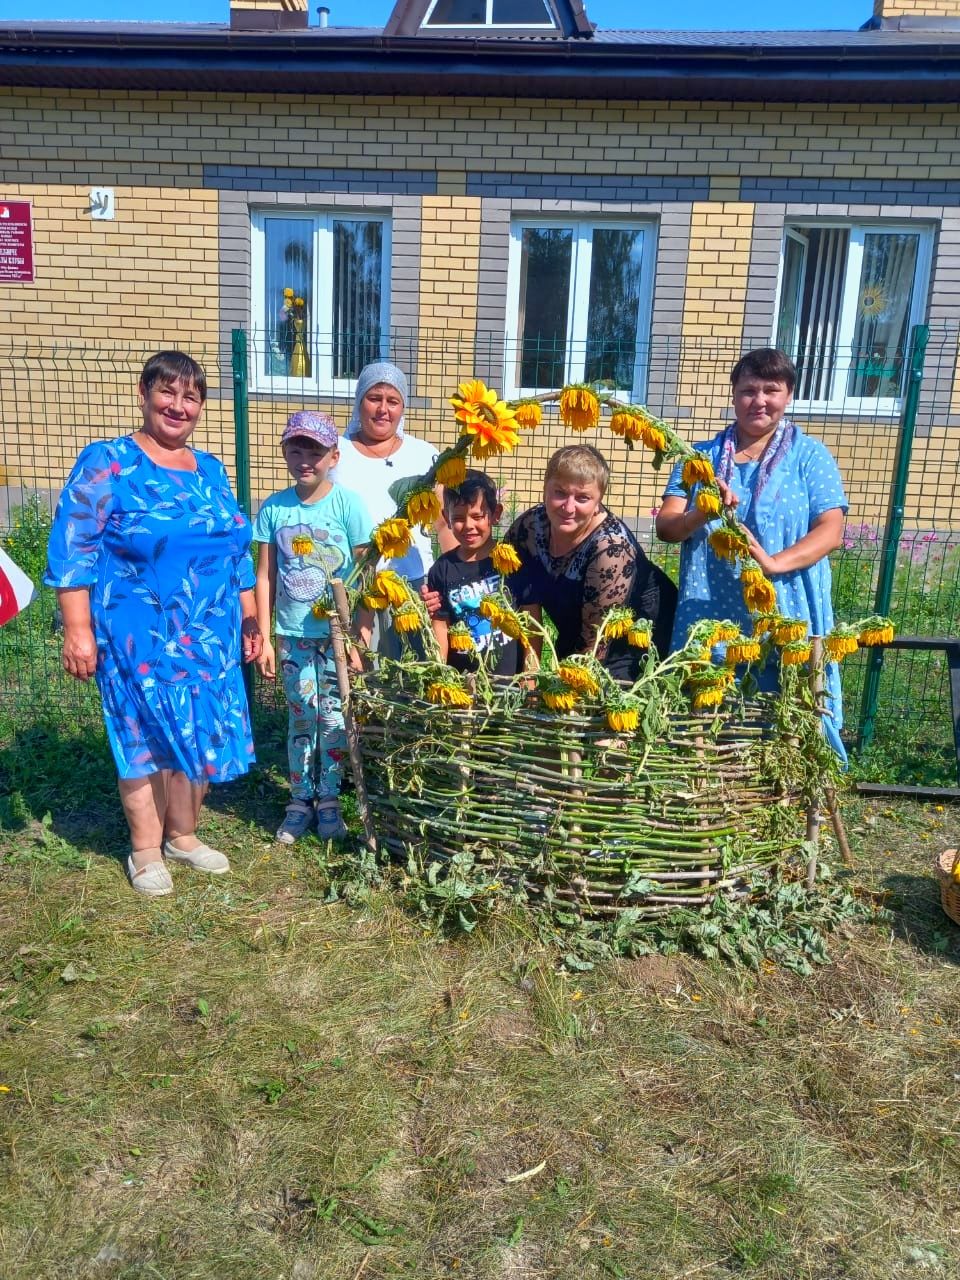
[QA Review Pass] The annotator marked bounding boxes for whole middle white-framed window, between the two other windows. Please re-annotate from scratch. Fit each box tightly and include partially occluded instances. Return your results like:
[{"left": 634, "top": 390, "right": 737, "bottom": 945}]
[{"left": 504, "top": 221, "right": 654, "bottom": 396}]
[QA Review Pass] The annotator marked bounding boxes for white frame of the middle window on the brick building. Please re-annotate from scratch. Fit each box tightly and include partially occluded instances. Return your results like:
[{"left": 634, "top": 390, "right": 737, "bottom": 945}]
[{"left": 503, "top": 212, "right": 658, "bottom": 401}]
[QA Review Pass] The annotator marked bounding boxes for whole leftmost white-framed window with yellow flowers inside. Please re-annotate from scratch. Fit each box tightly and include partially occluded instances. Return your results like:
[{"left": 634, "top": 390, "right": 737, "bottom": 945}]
[{"left": 251, "top": 212, "right": 389, "bottom": 390}]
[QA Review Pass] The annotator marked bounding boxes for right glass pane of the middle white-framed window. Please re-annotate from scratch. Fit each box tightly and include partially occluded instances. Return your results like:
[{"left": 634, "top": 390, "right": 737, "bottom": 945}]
[{"left": 584, "top": 227, "right": 644, "bottom": 388}]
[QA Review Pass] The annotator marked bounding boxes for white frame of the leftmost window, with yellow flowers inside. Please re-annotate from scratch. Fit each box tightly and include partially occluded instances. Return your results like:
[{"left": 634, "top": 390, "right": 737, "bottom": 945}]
[{"left": 250, "top": 205, "right": 390, "bottom": 397}]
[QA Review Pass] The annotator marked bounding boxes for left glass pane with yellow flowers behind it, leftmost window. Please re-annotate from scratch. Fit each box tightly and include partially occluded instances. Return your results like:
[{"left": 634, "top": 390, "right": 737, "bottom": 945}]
[{"left": 262, "top": 218, "right": 315, "bottom": 376}]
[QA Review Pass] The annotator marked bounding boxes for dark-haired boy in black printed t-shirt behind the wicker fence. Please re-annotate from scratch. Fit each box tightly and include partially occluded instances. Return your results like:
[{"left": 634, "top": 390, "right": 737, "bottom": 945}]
[{"left": 426, "top": 471, "right": 522, "bottom": 676}]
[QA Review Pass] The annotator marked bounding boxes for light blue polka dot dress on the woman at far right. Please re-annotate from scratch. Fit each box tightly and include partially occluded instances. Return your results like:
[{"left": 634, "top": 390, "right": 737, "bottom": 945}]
[{"left": 663, "top": 422, "right": 847, "bottom": 762}]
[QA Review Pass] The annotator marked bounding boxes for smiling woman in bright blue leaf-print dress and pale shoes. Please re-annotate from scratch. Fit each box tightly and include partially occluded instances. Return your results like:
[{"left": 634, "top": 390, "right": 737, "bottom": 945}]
[{"left": 45, "top": 351, "right": 261, "bottom": 896}]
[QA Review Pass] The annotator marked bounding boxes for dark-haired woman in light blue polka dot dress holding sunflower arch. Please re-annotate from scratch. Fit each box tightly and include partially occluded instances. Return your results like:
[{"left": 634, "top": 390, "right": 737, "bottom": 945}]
[{"left": 657, "top": 347, "right": 847, "bottom": 762}]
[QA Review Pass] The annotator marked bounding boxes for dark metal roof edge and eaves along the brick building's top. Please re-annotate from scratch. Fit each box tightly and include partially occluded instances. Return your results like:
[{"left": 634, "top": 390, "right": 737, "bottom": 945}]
[{"left": 0, "top": 19, "right": 960, "bottom": 102}]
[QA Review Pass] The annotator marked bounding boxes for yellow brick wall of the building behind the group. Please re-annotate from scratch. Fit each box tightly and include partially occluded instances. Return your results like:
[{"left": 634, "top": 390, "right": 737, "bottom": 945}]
[{"left": 0, "top": 87, "right": 960, "bottom": 524}]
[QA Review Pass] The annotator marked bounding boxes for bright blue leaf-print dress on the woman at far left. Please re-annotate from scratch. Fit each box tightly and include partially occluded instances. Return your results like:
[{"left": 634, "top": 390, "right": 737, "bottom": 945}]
[{"left": 44, "top": 436, "right": 255, "bottom": 783}]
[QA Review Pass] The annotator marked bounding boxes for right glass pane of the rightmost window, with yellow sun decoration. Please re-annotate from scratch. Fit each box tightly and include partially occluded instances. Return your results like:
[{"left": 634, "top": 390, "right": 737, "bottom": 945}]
[{"left": 847, "top": 232, "right": 919, "bottom": 397}]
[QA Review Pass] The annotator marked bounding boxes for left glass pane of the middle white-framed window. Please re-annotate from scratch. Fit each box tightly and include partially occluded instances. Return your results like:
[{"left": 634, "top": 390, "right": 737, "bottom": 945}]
[{"left": 517, "top": 227, "right": 573, "bottom": 388}]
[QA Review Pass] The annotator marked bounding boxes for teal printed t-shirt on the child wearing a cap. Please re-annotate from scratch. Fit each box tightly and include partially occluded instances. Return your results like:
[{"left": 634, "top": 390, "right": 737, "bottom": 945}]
[{"left": 253, "top": 484, "right": 372, "bottom": 636}]
